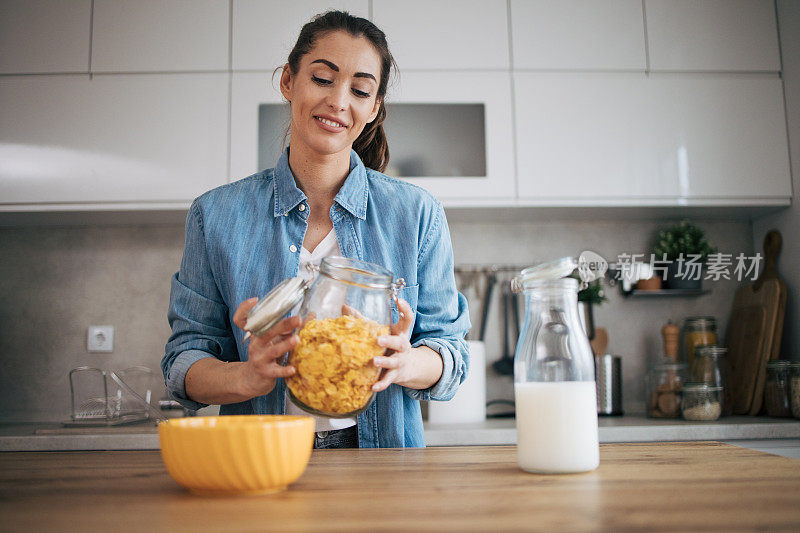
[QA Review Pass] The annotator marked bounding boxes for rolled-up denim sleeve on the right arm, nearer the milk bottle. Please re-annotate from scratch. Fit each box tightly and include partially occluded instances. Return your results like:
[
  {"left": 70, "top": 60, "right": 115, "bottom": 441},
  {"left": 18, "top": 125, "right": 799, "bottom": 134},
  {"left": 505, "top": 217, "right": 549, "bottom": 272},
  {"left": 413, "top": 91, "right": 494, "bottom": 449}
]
[{"left": 405, "top": 201, "right": 470, "bottom": 400}]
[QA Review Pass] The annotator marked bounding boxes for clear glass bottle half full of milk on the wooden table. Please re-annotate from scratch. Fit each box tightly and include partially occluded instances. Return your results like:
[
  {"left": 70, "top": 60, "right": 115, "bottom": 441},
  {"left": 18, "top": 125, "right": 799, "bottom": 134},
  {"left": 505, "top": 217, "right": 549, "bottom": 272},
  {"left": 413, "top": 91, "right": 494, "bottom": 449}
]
[{"left": 514, "top": 271, "right": 600, "bottom": 474}]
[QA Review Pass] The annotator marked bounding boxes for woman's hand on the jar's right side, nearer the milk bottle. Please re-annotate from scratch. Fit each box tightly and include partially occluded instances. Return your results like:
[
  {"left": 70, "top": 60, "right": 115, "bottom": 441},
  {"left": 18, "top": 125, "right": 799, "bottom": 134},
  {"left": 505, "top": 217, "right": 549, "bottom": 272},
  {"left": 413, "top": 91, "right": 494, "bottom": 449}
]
[{"left": 372, "top": 299, "right": 444, "bottom": 392}]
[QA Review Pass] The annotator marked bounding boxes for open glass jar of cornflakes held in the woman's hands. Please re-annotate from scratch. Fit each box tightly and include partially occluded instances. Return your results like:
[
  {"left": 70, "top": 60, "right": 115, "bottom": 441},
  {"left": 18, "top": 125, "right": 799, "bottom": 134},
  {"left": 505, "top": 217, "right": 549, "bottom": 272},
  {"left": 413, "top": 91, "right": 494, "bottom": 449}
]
[{"left": 245, "top": 256, "right": 405, "bottom": 418}]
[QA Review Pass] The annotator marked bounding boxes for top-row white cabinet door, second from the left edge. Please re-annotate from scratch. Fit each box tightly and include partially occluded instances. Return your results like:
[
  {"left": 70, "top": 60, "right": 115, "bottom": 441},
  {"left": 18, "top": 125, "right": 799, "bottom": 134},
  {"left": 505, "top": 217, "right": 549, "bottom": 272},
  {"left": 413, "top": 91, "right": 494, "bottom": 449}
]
[{"left": 92, "top": 0, "right": 229, "bottom": 72}]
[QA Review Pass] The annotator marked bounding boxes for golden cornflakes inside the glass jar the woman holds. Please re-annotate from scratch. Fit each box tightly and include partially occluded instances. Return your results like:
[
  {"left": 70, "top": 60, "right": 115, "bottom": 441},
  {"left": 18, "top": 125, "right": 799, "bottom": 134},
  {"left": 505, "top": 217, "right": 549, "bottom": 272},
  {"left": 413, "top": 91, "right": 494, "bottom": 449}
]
[{"left": 286, "top": 315, "right": 389, "bottom": 415}]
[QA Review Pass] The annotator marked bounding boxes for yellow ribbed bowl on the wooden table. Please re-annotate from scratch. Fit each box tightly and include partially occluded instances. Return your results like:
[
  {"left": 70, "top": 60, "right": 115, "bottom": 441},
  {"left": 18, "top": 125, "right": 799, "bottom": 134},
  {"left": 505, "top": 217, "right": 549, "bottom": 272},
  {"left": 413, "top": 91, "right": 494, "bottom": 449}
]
[{"left": 158, "top": 415, "right": 314, "bottom": 494}]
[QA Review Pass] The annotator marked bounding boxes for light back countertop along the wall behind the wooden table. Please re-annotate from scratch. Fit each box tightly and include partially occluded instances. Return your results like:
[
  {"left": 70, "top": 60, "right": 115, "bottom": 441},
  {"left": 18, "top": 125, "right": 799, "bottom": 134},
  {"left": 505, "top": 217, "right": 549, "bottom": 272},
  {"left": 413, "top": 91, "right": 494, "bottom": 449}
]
[{"left": 0, "top": 416, "right": 800, "bottom": 451}]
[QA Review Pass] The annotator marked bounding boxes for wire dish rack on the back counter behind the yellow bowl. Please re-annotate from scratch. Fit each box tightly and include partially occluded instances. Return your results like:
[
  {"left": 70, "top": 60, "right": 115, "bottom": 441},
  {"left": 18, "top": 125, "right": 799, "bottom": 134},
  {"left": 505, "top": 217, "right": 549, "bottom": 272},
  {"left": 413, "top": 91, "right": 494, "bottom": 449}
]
[{"left": 63, "top": 366, "right": 164, "bottom": 427}]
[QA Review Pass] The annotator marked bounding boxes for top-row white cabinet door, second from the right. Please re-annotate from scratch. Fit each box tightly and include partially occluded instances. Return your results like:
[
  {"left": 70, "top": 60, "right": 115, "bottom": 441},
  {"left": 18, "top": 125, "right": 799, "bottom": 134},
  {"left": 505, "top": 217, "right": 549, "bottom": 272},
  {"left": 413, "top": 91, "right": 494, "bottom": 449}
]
[{"left": 510, "top": 0, "right": 647, "bottom": 71}]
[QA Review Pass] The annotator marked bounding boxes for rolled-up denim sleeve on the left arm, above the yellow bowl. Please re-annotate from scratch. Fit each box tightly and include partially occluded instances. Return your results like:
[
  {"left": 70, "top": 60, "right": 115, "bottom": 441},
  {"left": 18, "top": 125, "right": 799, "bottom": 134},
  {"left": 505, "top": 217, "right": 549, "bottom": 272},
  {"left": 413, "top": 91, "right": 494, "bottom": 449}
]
[{"left": 161, "top": 202, "right": 236, "bottom": 409}]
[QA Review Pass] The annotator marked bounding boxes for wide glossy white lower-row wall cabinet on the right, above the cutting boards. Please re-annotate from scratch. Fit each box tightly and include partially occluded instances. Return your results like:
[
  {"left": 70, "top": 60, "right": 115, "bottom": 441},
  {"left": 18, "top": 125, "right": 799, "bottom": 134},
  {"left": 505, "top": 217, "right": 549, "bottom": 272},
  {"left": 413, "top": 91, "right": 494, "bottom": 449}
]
[{"left": 515, "top": 73, "right": 791, "bottom": 206}]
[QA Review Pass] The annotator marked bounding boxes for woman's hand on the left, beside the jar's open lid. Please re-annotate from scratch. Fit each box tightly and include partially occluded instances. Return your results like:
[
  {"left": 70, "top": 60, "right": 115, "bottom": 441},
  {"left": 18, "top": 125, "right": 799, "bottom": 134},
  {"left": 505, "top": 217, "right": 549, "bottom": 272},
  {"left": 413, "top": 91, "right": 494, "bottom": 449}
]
[{"left": 233, "top": 298, "right": 300, "bottom": 397}]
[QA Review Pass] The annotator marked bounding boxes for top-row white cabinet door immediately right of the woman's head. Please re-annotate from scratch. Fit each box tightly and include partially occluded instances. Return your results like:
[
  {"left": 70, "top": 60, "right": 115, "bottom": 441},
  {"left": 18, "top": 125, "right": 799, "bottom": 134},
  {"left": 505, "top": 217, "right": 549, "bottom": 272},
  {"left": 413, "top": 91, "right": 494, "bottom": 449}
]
[{"left": 372, "top": 0, "right": 509, "bottom": 71}]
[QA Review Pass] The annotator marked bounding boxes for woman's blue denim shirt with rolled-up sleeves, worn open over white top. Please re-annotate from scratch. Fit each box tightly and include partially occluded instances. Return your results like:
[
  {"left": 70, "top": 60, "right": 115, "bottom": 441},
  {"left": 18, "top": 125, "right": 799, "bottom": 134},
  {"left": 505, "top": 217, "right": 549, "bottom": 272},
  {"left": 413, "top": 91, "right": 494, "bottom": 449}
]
[{"left": 161, "top": 149, "right": 470, "bottom": 448}]
